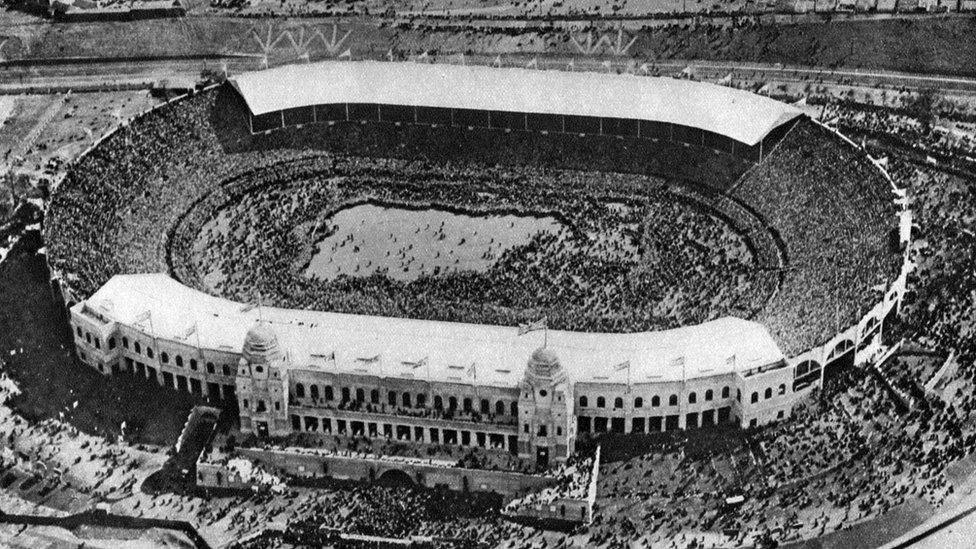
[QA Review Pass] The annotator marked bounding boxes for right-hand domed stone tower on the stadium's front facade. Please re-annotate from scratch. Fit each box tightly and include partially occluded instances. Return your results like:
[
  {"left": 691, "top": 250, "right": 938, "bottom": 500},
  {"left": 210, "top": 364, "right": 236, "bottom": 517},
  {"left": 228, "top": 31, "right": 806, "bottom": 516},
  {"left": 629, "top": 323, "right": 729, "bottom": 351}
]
[{"left": 519, "top": 347, "right": 576, "bottom": 467}]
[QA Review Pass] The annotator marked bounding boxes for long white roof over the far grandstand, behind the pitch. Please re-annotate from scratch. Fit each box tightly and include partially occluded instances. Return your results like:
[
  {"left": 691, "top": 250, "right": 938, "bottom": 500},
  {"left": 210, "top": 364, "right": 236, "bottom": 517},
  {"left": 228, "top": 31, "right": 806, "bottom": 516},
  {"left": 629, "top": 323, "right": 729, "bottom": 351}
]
[{"left": 231, "top": 61, "right": 802, "bottom": 146}]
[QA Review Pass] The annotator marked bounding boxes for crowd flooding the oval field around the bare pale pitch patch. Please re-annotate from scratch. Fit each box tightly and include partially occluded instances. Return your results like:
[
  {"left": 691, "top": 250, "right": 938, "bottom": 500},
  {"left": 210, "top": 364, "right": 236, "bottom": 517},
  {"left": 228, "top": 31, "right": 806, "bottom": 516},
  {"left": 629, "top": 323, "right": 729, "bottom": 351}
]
[{"left": 174, "top": 152, "right": 775, "bottom": 331}]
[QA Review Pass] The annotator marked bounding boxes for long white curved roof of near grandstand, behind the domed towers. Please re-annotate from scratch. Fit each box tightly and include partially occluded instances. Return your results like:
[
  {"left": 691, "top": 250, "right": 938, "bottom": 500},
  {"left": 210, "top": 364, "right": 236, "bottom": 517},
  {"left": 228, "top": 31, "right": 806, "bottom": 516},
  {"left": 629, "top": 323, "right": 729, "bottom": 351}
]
[{"left": 75, "top": 274, "right": 784, "bottom": 387}]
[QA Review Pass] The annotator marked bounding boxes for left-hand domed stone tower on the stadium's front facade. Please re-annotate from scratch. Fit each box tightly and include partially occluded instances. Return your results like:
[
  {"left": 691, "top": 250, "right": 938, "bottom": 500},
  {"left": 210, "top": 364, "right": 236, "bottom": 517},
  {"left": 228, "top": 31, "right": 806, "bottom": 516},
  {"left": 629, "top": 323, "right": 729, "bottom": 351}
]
[{"left": 236, "top": 322, "right": 289, "bottom": 436}]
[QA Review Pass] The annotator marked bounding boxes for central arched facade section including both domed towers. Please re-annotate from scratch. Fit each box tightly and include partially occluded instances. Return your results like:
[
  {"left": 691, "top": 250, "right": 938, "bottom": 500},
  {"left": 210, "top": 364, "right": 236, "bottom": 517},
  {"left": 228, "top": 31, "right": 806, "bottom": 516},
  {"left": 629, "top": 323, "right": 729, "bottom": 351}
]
[{"left": 236, "top": 322, "right": 576, "bottom": 466}]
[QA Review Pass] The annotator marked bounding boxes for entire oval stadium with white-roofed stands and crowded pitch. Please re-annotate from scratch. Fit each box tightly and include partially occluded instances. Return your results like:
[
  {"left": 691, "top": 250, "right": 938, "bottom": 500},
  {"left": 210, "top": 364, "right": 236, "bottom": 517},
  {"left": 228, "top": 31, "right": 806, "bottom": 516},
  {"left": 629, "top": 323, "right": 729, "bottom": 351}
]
[{"left": 45, "top": 58, "right": 910, "bottom": 496}]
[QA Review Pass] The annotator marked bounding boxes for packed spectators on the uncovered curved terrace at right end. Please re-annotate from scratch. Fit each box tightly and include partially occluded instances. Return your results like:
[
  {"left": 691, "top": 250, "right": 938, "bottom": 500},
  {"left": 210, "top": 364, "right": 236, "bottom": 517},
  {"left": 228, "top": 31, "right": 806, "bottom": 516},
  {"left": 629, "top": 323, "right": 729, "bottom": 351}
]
[{"left": 731, "top": 117, "right": 902, "bottom": 355}]
